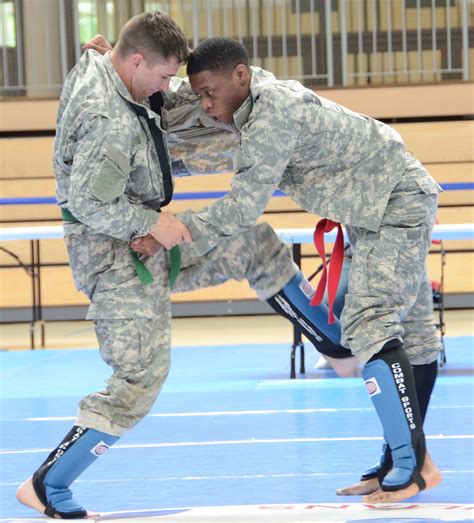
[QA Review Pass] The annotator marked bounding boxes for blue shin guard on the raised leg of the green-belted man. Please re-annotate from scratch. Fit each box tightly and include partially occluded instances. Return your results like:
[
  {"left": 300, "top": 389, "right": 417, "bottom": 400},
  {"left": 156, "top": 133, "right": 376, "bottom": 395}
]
[{"left": 267, "top": 271, "right": 352, "bottom": 358}]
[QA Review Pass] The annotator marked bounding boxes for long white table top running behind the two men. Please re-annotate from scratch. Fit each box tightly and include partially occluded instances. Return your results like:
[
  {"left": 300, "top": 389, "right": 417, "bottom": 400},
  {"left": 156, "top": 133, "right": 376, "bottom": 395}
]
[{"left": 0, "top": 223, "right": 474, "bottom": 244}]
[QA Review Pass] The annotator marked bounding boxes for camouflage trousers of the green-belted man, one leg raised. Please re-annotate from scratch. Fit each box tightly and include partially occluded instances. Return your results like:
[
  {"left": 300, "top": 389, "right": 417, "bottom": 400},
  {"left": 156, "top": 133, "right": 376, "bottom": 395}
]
[{"left": 67, "top": 224, "right": 296, "bottom": 436}]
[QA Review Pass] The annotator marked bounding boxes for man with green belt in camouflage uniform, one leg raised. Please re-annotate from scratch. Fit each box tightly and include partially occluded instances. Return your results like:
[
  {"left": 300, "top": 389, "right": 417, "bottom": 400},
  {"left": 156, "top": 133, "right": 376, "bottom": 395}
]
[{"left": 17, "top": 13, "right": 360, "bottom": 519}]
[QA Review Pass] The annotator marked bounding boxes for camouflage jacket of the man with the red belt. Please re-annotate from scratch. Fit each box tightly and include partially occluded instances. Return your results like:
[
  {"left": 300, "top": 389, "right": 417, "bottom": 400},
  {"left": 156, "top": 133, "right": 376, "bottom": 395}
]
[{"left": 180, "top": 67, "right": 438, "bottom": 253}]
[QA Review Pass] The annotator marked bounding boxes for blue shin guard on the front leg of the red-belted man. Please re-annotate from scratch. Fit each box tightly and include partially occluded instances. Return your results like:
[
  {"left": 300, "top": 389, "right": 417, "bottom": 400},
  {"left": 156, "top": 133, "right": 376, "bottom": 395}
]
[{"left": 362, "top": 346, "right": 426, "bottom": 491}]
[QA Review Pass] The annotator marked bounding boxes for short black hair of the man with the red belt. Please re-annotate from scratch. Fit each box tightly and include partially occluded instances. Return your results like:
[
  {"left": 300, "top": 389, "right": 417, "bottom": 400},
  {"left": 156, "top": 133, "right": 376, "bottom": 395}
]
[{"left": 187, "top": 37, "right": 249, "bottom": 76}]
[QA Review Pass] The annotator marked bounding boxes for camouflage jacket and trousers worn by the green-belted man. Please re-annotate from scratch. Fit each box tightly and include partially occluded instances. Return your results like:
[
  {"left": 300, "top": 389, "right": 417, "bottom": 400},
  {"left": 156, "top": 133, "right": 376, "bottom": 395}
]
[{"left": 54, "top": 51, "right": 296, "bottom": 436}]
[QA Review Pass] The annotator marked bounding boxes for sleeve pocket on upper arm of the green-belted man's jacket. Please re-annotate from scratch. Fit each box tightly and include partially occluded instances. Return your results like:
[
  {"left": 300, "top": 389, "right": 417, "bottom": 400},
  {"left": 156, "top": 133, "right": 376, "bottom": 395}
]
[{"left": 91, "top": 145, "right": 130, "bottom": 203}]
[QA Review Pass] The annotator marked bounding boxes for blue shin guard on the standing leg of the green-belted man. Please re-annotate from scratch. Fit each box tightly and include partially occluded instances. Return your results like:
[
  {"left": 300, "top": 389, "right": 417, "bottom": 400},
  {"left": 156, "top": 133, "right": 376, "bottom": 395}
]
[{"left": 33, "top": 426, "right": 119, "bottom": 519}]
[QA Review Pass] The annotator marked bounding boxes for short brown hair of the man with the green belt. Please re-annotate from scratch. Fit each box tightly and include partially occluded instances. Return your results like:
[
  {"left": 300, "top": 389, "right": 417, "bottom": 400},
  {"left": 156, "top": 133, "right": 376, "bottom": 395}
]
[{"left": 116, "top": 11, "right": 189, "bottom": 63}]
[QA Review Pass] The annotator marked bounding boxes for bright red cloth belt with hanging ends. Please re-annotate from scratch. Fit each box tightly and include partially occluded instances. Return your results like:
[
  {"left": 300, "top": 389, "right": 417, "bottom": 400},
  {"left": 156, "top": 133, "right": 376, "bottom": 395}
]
[{"left": 311, "top": 218, "right": 344, "bottom": 325}]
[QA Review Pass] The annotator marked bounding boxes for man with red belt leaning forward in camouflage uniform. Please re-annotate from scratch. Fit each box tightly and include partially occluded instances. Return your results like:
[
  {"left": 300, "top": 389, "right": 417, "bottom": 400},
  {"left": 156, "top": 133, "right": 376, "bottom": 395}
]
[{"left": 168, "top": 38, "right": 441, "bottom": 502}]
